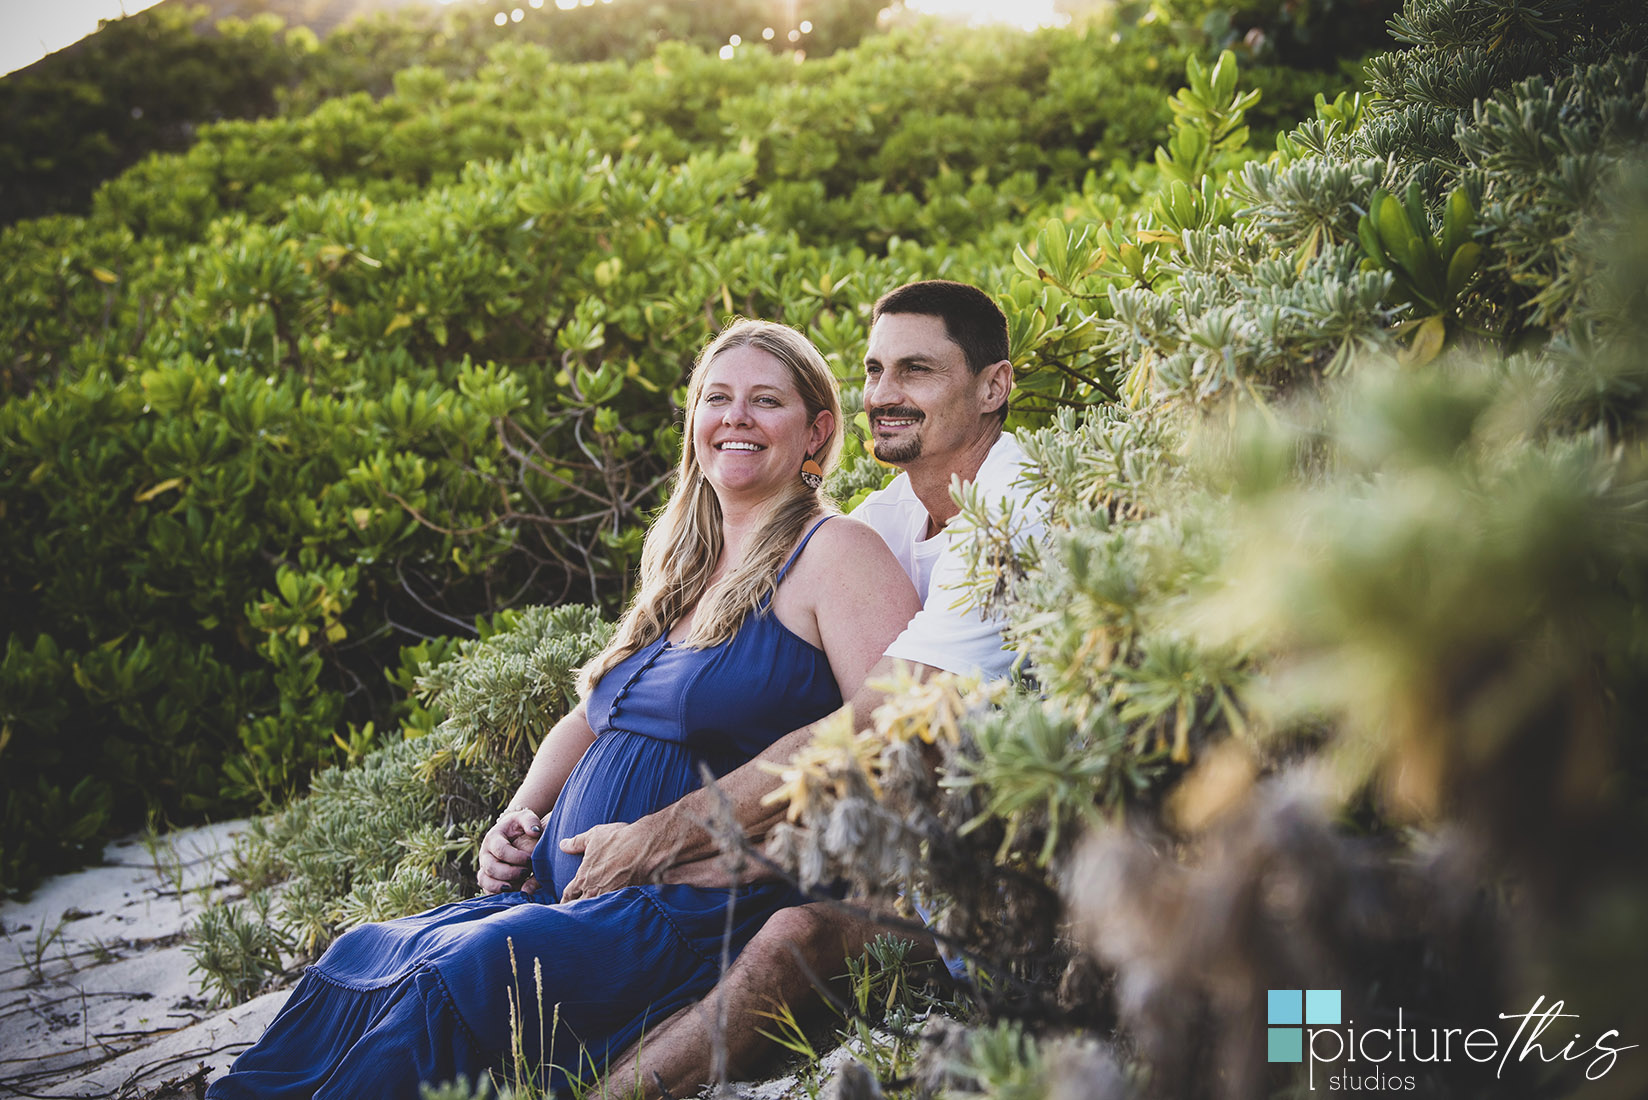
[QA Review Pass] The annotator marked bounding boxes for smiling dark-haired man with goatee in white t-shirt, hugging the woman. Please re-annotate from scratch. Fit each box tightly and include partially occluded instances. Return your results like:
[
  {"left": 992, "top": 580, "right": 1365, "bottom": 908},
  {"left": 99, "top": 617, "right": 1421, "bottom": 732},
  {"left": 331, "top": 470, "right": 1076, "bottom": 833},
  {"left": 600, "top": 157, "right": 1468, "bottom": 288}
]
[{"left": 481, "top": 280, "right": 1040, "bottom": 1097}]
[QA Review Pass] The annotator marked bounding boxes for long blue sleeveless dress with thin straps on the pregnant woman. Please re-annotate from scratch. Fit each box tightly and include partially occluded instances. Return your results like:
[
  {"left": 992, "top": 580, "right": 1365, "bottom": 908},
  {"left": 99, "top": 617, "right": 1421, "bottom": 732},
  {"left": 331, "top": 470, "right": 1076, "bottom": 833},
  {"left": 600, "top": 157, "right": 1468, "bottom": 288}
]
[{"left": 206, "top": 519, "right": 842, "bottom": 1100}]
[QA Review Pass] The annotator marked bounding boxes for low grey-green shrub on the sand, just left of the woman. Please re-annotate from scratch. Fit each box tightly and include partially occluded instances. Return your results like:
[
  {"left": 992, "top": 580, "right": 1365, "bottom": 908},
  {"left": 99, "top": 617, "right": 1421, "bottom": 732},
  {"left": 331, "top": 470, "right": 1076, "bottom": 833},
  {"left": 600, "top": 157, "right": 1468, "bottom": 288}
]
[{"left": 191, "top": 605, "right": 611, "bottom": 1001}]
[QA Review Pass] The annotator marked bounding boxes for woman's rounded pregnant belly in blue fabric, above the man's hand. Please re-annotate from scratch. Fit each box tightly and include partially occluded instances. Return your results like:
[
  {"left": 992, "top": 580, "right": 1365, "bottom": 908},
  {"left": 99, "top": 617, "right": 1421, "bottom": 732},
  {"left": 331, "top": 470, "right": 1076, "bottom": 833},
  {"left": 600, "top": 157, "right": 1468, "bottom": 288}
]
[{"left": 532, "top": 729, "right": 700, "bottom": 897}]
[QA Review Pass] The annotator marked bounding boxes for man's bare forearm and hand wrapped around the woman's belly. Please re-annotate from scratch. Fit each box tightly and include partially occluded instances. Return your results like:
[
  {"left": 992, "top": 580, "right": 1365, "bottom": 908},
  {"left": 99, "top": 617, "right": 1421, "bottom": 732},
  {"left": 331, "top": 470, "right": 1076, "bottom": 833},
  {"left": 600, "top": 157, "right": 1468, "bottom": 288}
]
[{"left": 560, "top": 656, "right": 933, "bottom": 900}]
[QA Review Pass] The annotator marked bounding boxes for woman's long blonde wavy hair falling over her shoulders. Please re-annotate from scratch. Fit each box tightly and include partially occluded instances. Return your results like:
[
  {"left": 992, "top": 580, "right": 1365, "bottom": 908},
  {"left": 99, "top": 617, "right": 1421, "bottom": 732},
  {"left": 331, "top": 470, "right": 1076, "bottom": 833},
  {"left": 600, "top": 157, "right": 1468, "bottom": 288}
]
[{"left": 578, "top": 320, "right": 842, "bottom": 694}]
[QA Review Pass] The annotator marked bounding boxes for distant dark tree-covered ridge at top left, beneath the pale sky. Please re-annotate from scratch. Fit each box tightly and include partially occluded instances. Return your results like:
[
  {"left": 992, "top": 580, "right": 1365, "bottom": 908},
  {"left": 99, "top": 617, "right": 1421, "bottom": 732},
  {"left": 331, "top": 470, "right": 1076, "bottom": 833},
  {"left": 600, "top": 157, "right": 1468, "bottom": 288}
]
[{"left": 0, "top": 0, "right": 880, "bottom": 224}]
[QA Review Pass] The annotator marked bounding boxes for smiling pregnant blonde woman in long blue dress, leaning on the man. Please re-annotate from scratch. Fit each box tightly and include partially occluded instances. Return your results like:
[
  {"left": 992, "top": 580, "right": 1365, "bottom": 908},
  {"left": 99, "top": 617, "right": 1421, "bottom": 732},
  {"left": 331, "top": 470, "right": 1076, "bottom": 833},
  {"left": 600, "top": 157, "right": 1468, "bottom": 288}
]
[{"left": 206, "top": 322, "right": 918, "bottom": 1100}]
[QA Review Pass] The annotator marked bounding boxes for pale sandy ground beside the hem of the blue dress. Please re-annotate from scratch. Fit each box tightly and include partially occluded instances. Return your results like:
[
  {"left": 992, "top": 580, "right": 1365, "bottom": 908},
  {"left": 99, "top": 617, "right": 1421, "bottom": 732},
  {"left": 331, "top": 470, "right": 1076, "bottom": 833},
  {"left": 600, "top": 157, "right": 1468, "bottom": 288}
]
[{"left": 0, "top": 821, "right": 845, "bottom": 1100}]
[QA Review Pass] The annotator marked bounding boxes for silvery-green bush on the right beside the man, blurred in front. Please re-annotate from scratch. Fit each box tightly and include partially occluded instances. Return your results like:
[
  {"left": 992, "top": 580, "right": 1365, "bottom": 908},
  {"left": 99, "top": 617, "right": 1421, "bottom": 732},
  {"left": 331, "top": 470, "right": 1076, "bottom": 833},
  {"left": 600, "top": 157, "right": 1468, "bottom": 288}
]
[{"left": 770, "top": 0, "right": 1648, "bottom": 1098}]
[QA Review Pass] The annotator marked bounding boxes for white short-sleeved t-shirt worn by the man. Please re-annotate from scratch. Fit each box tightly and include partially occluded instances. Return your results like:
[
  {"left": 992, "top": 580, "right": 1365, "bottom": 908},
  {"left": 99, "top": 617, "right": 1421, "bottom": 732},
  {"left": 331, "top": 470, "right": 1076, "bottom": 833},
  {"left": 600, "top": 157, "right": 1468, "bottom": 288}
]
[{"left": 852, "top": 432, "right": 1043, "bottom": 679}]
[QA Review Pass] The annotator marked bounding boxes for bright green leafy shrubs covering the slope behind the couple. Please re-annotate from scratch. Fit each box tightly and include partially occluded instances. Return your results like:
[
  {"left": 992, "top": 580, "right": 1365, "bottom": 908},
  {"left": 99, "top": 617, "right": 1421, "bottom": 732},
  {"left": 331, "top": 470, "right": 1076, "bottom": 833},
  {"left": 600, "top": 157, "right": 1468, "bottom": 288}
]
[{"left": 0, "top": 0, "right": 1338, "bottom": 884}]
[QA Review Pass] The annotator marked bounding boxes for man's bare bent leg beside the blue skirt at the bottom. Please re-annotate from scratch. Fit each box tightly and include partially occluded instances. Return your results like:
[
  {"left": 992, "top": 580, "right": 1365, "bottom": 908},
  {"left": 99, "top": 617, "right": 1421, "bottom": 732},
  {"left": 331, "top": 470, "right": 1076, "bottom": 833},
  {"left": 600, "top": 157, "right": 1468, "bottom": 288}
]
[{"left": 592, "top": 905, "right": 933, "bottom": 1100}]
